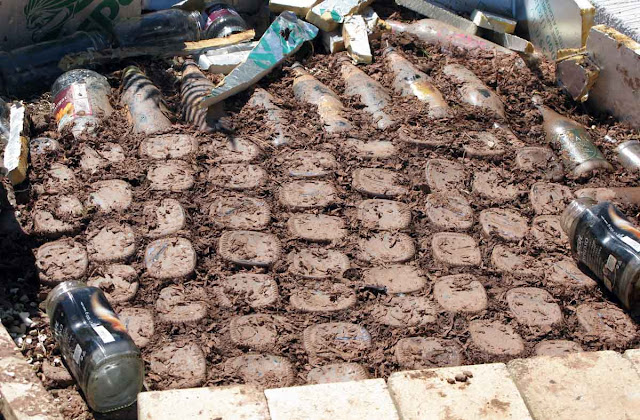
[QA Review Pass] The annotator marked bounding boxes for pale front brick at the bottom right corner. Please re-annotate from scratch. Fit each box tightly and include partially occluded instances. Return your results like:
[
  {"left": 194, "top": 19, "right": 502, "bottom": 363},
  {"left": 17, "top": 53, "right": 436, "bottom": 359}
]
[{"left": 508, "top": 351, "right": 640, "bottom": 420}]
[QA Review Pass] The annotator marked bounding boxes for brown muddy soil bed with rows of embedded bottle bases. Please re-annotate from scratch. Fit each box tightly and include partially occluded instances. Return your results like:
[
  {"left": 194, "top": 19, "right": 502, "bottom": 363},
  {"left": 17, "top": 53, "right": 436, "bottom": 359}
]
[{"left": 0, "top": 11, "right": 640, "bottom": 418}]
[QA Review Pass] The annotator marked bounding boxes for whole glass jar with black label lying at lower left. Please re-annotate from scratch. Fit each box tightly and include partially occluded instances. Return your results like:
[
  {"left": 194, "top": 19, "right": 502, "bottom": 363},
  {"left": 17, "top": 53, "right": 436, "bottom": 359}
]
[{"left": 45, "top": 281, "right": 144, "bottom": 413}]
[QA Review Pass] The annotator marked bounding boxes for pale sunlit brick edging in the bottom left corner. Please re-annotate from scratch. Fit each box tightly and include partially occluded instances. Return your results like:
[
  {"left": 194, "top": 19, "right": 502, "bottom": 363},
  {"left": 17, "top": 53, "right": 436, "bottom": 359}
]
[{"left": 0, "top": 324, "right": 63, "bottom": 420}]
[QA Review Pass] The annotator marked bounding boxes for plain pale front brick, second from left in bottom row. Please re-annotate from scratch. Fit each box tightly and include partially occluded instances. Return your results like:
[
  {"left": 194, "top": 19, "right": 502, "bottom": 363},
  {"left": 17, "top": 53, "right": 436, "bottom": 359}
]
[{"left": 264, "top": 379, "right": 400, "bottom": 420}]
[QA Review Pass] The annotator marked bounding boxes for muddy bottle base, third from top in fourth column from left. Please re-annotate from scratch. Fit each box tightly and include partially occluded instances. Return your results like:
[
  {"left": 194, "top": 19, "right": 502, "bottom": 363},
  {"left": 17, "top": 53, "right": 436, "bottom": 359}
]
[{"left": 209, "top": 196, "right": 271, "bottom": 230}]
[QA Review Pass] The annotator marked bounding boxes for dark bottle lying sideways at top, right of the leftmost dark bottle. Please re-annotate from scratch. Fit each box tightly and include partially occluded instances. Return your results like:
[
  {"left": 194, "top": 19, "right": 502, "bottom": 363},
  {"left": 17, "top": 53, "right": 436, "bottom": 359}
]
[{"left": 113, "top": 9, "right": 204, "bottom": 47}]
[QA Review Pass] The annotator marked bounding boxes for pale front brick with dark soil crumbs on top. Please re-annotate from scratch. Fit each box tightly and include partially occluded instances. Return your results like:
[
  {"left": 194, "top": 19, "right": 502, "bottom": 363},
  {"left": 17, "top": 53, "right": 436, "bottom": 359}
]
[{"left": 389, "top": 363, "right": 531, "bottom": 420}]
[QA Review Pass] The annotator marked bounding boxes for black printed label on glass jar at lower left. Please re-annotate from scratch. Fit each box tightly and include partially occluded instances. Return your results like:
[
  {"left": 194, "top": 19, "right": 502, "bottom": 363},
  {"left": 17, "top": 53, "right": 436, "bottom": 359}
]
[{"left": 51, "top": 287, "right": 135, "bottom": 385}]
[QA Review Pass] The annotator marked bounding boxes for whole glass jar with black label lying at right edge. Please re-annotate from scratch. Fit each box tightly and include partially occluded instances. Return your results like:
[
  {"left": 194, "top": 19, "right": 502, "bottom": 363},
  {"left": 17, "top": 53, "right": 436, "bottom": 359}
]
[{"left": 561, "top": 197, "right": 640, "bottom": 315}]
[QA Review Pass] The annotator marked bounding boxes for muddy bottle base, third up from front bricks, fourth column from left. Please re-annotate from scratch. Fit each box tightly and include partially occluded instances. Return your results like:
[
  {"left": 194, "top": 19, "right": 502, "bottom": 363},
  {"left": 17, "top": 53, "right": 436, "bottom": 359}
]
[{"left": 215, "top": 273, "right": 279, "bottom": 309}]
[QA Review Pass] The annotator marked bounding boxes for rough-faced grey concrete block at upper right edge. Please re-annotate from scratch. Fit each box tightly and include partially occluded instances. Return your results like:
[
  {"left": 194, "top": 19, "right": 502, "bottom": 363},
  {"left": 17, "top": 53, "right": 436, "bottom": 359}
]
[{"left": 587, "top": 25, "right": 640, "bottom": 128}]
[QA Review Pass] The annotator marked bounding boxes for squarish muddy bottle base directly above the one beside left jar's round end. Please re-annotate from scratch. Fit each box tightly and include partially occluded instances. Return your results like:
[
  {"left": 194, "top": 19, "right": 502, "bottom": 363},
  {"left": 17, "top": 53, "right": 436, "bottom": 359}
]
[{"left": 156, "top": 285, "right": 207, "bottom": 324}]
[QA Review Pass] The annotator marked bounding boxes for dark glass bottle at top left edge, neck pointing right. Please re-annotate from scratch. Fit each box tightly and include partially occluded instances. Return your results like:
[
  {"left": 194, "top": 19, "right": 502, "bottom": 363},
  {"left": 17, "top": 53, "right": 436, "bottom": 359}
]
[{"left": 0, "top": 32, "right": 111, "bottom": 96}]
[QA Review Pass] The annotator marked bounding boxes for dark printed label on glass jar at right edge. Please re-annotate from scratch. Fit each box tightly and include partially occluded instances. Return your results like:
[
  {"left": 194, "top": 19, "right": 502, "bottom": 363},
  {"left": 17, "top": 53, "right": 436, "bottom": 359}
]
[{"left": 572, "top": 202, "right": 640, "bottom": 307}]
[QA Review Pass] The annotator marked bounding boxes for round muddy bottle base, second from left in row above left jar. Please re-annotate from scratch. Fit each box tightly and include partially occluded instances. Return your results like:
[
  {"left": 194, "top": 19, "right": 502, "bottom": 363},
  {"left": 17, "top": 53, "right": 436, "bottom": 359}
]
[{"left": 87, "top": 222, "right": 136, "bottom": 263}]
